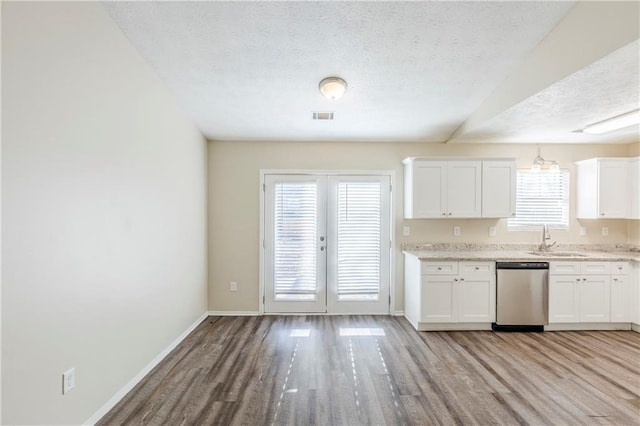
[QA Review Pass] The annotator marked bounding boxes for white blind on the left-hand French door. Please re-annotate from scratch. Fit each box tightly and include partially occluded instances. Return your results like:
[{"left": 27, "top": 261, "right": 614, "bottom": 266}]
[{"left": 274, "top": 182, "right": 318, "bottom": 300}]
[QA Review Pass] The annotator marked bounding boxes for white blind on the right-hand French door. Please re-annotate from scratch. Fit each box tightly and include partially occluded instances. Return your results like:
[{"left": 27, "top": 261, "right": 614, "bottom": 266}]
[{"left": 337, "top": 182, "right": 382, "bottom": 300}]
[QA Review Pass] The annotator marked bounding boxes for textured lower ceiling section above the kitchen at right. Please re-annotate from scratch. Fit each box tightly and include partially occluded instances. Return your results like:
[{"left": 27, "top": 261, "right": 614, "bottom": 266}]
[{"left": 458, "top": 41, "right": 640, "bottom": 143}]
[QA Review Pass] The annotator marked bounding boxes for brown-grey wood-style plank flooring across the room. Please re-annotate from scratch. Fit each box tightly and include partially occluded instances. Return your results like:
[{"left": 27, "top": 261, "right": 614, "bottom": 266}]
[{"left": 98, "top": 316, "right": 640, "bottom": 426}]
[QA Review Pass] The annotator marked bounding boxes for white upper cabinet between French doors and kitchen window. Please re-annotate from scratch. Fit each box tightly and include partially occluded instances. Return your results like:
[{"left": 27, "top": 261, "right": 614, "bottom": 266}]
[{"left": 403, "top": 158, "right": 516, "bottom": 219}]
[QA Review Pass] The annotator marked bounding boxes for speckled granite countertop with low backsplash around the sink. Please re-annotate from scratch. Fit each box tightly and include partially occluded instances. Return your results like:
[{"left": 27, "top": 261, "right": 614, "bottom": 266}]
[{"left": 403, "top": 243, "right": 640, "bottom": 262}]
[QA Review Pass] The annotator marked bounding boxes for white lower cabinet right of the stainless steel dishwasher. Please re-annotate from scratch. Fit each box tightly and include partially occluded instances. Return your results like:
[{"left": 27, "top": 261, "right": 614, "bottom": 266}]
[{"left": 549, "top": 262, "right": 632, "bottom": 323}]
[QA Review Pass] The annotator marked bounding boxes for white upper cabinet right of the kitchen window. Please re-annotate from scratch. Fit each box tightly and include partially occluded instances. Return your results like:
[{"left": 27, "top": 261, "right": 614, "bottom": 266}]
[{"left": 576, "top": 158, "right": 638, "bottom": 219}]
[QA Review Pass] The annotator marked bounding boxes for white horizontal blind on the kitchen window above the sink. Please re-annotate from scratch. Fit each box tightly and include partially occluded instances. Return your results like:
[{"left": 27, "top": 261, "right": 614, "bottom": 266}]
[{"left": 508, "top": 170, "right": 569, "bottom": 230}]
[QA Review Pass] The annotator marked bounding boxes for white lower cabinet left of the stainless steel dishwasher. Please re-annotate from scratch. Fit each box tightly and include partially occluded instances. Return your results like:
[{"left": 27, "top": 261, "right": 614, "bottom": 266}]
[{"left": 405, "top": 255, "right": 496, "bottom": 330}]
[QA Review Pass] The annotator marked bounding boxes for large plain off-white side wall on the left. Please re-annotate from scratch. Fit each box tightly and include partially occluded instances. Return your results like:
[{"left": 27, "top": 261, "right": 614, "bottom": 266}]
[{"left": 2, "top": 2, "right": 207, "bottom": 425}]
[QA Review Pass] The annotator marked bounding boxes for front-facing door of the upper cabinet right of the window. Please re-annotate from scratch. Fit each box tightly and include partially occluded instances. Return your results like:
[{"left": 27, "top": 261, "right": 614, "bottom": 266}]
[{"left": 598, "top": 159, "right": 631, "bottom": 219}]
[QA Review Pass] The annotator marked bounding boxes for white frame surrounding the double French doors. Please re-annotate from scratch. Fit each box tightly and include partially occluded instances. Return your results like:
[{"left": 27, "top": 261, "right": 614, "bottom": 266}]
[{"left": 258, "top": 169, "right": 397, "bottom": 315}]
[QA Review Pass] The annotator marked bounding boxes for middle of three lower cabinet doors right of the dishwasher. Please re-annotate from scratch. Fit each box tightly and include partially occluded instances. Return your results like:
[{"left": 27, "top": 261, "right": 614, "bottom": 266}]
[{"left": 578, "top": 275, "right": 611, "bottom": 322}]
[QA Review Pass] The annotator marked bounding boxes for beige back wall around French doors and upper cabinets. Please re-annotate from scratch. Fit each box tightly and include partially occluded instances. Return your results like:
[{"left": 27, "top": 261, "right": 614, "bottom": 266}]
[{"left": 209, "top": 142, "right": 637, "bottom": 311}]
